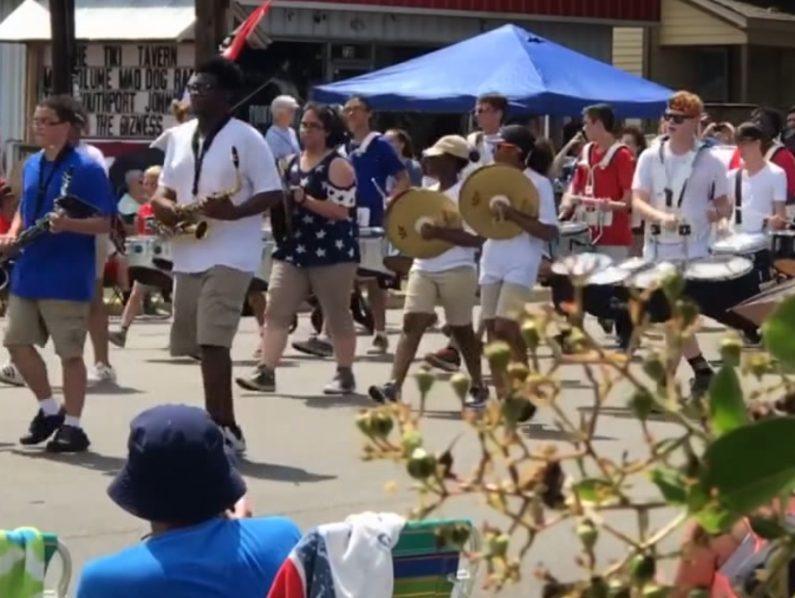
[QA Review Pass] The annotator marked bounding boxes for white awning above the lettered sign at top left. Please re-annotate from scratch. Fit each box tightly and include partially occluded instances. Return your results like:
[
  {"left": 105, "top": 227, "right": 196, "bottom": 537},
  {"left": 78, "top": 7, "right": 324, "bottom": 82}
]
[{"left": 0, "top": 0, "right": 196, "bottom": 42}]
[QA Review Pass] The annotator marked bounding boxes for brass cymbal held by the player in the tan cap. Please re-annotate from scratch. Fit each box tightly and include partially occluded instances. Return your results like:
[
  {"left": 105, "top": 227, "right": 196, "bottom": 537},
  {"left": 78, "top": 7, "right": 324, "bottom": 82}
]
[{"left": 384, "top": 187, "right": 462, "bottom": 258}]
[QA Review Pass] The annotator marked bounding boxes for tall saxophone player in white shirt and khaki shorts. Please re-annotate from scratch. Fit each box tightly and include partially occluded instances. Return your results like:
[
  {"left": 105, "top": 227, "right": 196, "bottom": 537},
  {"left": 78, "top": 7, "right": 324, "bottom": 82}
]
[{"left": 152, "top": 57, "right": 283, "bottom": 452}]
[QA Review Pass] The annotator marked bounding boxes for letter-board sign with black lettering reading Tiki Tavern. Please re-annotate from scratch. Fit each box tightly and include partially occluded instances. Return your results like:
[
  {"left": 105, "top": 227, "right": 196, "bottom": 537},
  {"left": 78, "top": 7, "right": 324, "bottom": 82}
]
[{"left": 40, "top": 43, "right": 194, "bottom": 139}]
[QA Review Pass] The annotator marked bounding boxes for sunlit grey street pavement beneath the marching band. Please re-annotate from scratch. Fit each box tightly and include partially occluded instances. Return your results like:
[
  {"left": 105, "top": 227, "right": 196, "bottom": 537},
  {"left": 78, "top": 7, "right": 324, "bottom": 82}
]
[{"left": 0, "top": 310, "right": 736, "bottom": 598}]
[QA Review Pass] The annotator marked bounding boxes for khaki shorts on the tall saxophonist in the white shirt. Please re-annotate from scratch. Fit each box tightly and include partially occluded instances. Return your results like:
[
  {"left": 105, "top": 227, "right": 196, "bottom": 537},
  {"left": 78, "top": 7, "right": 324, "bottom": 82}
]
[{"left": 170, "top": 266, "right": 251, "bottom": 357}]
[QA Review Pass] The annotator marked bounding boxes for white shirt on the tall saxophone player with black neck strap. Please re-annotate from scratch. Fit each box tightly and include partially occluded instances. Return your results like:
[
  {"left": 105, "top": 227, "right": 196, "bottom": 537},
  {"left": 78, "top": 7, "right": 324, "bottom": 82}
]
[{"left": 160, "top": 118, "right": 282, "bottom": 274}]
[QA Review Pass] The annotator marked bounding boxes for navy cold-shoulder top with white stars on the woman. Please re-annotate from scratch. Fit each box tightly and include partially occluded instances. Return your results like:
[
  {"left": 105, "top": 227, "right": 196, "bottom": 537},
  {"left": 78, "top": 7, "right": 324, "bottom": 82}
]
[{"left": 273, "top": 152, "right": 359, "bottom": 268}]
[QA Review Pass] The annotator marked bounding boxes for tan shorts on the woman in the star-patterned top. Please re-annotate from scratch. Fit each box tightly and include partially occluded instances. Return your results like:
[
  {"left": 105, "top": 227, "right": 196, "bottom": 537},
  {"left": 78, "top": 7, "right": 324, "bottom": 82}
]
[{"left": 265, "top": 260, "right": 358, "bottom": 337}]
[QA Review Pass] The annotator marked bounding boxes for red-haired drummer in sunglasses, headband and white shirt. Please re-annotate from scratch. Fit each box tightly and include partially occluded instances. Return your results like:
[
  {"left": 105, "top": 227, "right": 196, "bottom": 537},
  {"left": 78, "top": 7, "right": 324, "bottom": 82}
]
[{"left": 632, "top": 91, "right": 731, "bottom": 394}]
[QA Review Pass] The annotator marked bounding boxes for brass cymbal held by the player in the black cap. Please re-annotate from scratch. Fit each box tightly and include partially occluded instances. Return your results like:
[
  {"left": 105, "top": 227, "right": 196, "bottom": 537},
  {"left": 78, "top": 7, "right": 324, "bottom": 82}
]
[{"left": 458, "top": 164, "right": 539, "bottom": 239}]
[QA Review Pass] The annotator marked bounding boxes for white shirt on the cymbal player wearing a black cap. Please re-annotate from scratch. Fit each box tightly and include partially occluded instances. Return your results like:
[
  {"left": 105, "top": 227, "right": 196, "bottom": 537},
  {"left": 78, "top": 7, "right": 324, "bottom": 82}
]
[{"left": 480, "top": 168, "right": 558, "bottom": 289}]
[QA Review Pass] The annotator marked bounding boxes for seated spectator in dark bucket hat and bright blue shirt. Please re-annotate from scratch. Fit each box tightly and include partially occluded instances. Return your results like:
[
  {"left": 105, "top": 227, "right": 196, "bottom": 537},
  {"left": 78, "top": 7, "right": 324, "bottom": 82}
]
[{"left": 77, "top": 405, "right": 301, "bottom": 598}]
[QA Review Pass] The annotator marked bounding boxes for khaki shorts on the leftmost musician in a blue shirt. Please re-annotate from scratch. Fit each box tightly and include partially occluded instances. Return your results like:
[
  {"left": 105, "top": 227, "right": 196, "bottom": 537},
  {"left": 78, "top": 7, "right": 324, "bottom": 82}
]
[{"left": 3, "top": 295, "right": 91, "bottom": 359}]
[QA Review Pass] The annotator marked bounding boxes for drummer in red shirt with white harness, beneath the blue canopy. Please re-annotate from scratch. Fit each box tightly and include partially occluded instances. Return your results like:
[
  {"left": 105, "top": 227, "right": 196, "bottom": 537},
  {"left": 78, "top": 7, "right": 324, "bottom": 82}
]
[{"left": 561, "top": 104, "right": 635, "bottom": 347}]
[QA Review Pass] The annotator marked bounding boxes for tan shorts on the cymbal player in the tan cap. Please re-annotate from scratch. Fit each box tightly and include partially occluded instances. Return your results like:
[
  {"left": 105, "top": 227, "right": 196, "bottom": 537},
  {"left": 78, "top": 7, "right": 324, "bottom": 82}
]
[{"left": 403, "top": 266, "right": 478, "bottom": 326}]
